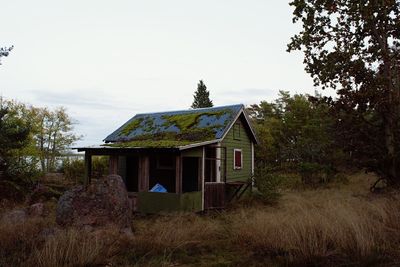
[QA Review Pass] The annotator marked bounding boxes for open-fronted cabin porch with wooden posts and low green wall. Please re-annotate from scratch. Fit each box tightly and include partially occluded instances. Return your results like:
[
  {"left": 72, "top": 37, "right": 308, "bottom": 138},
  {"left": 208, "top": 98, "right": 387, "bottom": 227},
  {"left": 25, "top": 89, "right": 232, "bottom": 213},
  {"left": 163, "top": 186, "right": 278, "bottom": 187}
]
[{"left": 78, "top": 145, "right": 231, "bottom": 214}]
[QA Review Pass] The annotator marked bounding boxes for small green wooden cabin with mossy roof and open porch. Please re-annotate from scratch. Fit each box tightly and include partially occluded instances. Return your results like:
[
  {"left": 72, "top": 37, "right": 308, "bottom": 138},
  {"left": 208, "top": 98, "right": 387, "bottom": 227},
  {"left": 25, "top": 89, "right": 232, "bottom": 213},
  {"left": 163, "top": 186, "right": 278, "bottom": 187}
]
[{"left": 78, "top": 105, "right": 257, "bottom": 213}]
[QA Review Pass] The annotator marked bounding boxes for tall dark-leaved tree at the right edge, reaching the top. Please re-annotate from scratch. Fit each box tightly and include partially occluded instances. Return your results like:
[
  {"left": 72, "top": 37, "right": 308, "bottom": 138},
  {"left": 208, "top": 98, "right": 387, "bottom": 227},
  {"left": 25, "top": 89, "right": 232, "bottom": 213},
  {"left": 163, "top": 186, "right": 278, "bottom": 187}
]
[{"left": 288, "top": 0, "right": 400, "bottom": 184}]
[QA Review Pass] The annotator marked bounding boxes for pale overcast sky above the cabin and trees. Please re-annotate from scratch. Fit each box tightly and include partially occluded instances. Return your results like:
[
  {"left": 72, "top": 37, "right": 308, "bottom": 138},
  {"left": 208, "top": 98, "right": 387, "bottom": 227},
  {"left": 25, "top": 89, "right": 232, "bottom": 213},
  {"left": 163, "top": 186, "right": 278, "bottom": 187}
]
[{"left": 0, "top": 0, "right": 324, "bottom": 146}]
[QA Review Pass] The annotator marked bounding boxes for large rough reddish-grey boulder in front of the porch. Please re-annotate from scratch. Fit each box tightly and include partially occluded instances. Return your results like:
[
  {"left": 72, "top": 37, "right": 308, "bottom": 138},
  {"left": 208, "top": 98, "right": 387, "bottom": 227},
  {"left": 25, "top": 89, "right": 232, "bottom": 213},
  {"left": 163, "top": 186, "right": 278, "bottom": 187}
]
[{"left": 56, "top": 175, "right": 132, "bottom": 230}]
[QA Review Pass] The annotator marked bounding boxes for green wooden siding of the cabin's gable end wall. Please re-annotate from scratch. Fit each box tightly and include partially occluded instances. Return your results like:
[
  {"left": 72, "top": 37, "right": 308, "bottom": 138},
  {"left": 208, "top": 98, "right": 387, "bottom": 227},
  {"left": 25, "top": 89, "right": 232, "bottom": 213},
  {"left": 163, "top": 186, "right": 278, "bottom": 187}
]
[{"left": 221, "top": 118, "right": 252, "bottom": 181}]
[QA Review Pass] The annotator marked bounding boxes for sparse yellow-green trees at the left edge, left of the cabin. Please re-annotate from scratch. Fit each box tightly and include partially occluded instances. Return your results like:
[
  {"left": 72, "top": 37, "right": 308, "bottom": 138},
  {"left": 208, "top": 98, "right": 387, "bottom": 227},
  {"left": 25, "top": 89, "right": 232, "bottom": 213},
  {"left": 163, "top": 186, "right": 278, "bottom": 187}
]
[{"left": 0, "top": 98, "right": 80, "bottom": 175}]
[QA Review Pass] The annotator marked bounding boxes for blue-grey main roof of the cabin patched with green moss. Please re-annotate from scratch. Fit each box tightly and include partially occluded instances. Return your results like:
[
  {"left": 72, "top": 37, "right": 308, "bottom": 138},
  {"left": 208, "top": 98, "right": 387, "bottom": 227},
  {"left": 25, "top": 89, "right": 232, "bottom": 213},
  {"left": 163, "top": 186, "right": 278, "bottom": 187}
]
[{"left": 104, "top": 105, "right": 244, "bottom": 147}]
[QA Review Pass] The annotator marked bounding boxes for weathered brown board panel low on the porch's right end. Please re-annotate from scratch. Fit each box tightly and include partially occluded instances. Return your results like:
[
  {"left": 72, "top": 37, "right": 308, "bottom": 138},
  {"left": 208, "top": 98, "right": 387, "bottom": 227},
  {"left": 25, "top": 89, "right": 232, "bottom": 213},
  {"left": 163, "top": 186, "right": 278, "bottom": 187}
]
[{"left": 204, "top": 182, "right": 226, "bottom": 209}]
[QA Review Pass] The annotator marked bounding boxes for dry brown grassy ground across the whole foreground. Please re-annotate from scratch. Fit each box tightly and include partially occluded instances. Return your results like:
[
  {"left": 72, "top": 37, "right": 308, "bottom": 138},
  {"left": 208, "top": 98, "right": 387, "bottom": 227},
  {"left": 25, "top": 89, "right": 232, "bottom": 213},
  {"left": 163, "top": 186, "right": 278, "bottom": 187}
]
[{"left": 0, "top": 173, "right": 400, "bottom": 266}]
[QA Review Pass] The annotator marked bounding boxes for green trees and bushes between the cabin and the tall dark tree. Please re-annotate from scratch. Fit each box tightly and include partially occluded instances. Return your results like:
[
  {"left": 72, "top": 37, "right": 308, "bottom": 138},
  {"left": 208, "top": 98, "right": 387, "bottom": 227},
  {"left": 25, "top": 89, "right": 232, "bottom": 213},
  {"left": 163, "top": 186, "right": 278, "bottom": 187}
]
[{"left": 248, "top": 91, "right": 346, "bottom": 184}]
